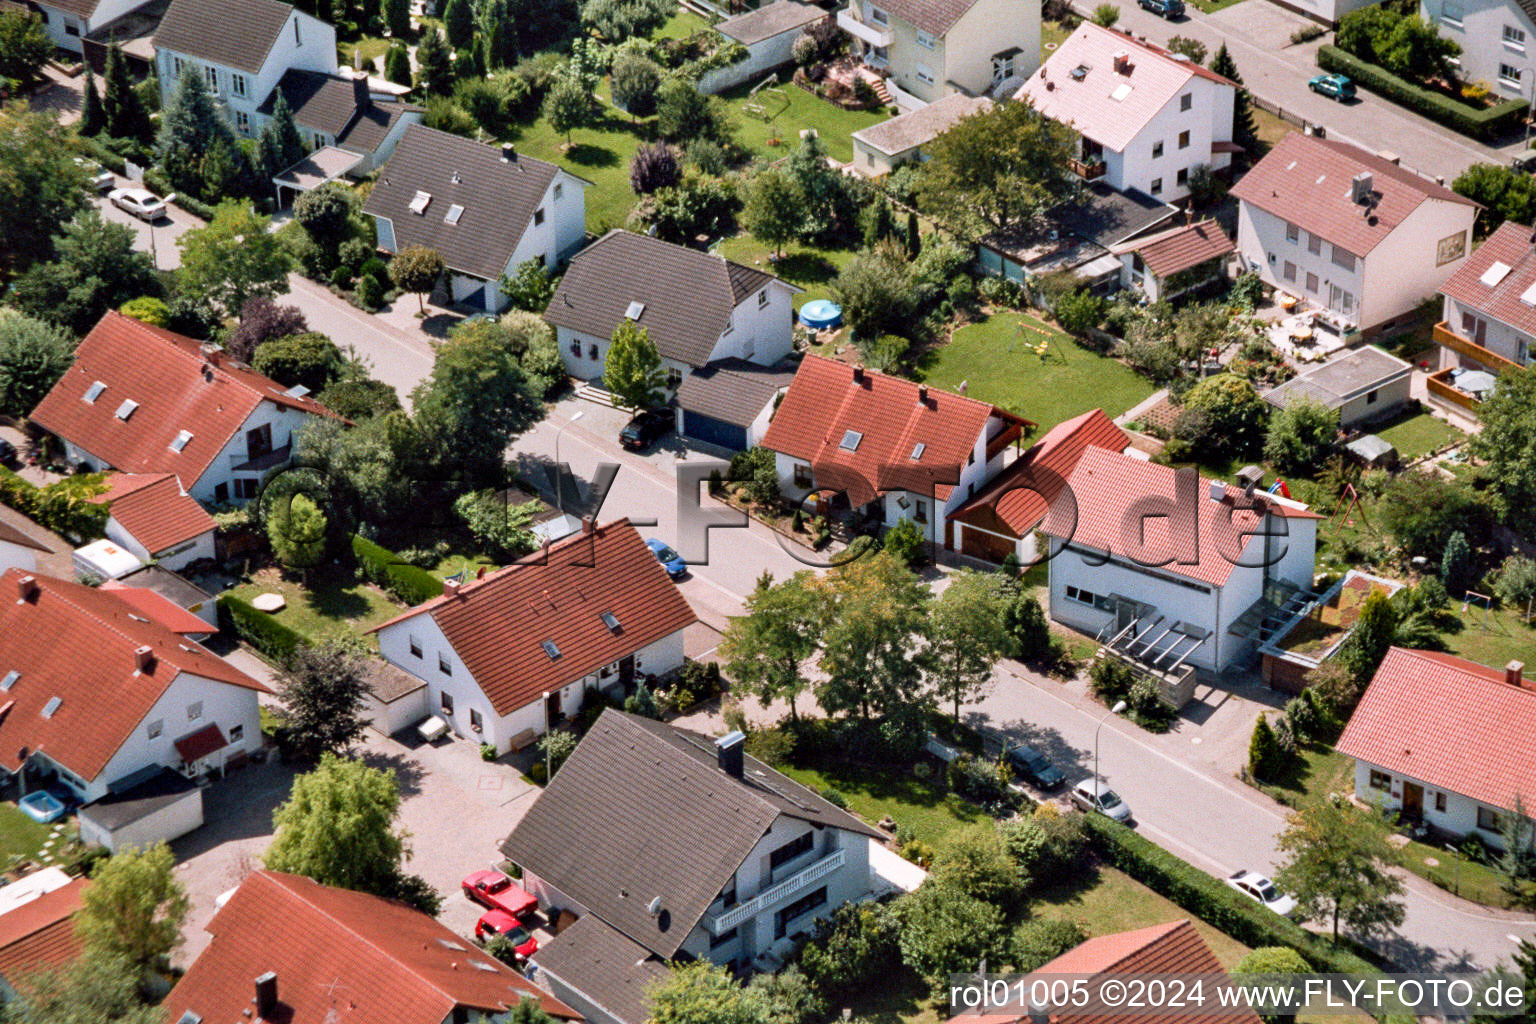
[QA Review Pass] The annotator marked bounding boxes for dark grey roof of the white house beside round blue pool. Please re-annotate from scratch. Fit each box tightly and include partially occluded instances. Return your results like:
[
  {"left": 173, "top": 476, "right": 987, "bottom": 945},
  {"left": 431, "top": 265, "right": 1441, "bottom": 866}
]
[{"left": 543, "top": 234, "right": 777, "bottom": 367}]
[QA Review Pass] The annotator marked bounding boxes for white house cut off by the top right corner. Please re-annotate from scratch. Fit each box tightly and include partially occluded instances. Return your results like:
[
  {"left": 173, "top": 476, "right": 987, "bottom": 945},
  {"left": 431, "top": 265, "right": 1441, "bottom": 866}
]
[{"left": 1419, "top": 0, "right": 1536, "bottom": 92}]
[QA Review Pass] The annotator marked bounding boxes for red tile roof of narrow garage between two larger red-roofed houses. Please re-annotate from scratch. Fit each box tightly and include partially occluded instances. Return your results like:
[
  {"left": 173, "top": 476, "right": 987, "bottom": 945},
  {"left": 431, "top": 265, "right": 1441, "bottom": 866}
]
[{"left": 949, "top": 408, "right": 1130, "bottom": 537}]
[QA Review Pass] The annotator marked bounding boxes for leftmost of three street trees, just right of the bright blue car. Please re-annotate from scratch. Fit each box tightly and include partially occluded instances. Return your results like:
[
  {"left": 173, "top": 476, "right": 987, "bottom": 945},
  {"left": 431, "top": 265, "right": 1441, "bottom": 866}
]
[{"left": 720, "top": 573, "right": 820, "bottom": 720}]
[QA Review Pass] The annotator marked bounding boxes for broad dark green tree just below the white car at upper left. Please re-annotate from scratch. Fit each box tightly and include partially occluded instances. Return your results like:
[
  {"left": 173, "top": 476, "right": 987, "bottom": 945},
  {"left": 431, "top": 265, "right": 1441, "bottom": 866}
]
[{"left": 11, "top": 209, "right": 160, "bottom": 335}]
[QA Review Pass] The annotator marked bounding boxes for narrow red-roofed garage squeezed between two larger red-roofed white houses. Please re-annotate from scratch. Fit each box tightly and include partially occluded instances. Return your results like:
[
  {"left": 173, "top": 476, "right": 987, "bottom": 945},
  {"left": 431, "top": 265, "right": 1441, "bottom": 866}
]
[{"left": 949, "top": 408, "right": 1130, "bottom": 565}]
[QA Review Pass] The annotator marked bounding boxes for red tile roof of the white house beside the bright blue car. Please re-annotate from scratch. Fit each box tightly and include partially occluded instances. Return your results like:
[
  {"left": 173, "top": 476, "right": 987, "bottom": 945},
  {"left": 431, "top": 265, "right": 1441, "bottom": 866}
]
[{"left": 373, "top": 519, "right": 697, "bottom": 715}]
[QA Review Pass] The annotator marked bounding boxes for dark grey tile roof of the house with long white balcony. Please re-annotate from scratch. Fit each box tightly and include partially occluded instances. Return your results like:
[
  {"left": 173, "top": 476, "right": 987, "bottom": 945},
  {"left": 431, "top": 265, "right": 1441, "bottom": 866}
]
[{"left": 501, "top": 709, "right": 879, "bottom": 958}]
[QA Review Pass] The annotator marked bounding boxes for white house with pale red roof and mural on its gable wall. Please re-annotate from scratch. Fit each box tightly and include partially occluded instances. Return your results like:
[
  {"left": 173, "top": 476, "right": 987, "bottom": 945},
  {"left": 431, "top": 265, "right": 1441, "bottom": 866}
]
[{"left": 1232, "top": 132, "right": 1479, "bottom": 336}]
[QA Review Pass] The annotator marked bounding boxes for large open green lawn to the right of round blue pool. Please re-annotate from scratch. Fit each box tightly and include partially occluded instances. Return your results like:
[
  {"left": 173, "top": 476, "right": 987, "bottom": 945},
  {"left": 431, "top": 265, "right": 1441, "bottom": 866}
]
[{"left": 922, "top": 312, "right": 1154, "bottom": 431}]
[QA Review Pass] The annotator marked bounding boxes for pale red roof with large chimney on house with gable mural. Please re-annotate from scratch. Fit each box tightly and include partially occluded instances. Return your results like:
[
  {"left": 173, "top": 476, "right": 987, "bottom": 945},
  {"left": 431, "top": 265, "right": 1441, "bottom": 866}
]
[{"left": 1232, "top": 132, "right": 1481, "bottom": 256}]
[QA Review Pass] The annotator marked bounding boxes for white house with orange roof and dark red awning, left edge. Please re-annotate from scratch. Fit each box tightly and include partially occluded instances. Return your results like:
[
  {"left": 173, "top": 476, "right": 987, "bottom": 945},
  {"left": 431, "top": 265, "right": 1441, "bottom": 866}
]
[{"left": 0, "top": 570, "right": 266, "bottom": 846}]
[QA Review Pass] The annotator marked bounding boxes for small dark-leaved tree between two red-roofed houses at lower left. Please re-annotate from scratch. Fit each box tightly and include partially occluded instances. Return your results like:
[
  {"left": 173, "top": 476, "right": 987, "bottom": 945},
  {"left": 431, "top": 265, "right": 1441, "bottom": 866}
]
[{"left": 278, "top": 644, "right": 369, "bottom": 761}]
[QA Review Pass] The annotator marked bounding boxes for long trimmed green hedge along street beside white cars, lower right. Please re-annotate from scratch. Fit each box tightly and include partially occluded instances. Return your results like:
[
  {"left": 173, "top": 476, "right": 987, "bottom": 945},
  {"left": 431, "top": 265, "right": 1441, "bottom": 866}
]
[{"left": 1083, "top": 814, "right": 1379, "bottom": 973}]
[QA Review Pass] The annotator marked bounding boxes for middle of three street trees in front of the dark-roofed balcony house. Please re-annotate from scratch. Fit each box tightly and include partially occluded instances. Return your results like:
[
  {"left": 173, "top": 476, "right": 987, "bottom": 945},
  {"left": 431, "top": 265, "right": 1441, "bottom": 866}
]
[{"left": 816, "top": 551, "right": 929, "bottom": 718}]
